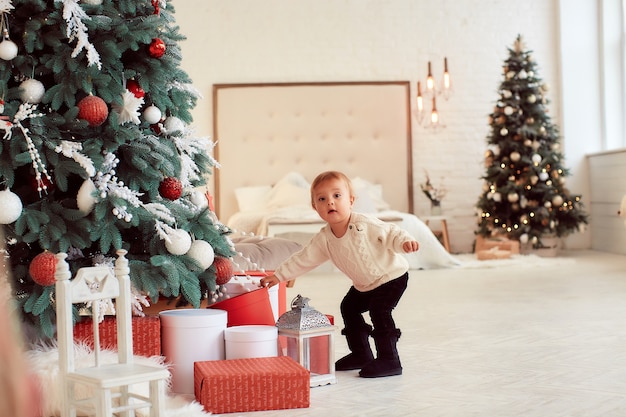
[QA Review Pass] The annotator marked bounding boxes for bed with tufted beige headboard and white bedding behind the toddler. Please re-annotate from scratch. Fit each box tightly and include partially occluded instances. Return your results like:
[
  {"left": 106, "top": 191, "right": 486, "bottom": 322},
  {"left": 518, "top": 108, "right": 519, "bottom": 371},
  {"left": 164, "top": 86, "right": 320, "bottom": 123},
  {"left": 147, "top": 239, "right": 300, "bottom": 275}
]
[{"left": 213, "top": 81, "right": 459, "bottom": 269}]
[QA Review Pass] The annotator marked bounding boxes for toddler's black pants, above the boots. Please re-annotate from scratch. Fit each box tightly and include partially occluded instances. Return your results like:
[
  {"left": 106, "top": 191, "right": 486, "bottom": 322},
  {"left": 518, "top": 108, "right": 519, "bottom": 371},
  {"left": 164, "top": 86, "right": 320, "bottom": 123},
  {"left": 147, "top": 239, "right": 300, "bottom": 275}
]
[{"left": 341, "top": 272, "right": 409, "bottom": 335}]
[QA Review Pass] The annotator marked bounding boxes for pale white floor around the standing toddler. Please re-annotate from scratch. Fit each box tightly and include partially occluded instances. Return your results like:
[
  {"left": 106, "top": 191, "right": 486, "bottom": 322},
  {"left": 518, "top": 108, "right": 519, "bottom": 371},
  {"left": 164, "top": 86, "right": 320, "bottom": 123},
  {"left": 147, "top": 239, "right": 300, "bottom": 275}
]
[{"left": 218, "top": 251, "right": 626, "bottom": 417}]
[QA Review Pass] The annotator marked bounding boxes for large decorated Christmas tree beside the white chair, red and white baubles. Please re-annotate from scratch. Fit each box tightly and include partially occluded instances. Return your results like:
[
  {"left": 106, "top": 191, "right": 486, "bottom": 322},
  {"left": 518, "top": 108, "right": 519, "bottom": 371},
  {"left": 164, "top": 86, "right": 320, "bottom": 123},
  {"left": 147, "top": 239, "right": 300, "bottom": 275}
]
[{"left": 0, "top": 0, "right": 234, "bottom": 336}]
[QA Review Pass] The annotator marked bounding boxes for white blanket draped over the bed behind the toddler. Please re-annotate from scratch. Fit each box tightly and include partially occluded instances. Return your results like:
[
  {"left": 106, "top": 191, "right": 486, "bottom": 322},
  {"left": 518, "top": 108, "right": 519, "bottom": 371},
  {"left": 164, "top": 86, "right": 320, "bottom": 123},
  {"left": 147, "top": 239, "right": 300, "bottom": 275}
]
[{"left": 227, "top": 206, "right": 461, "bottom": 269}]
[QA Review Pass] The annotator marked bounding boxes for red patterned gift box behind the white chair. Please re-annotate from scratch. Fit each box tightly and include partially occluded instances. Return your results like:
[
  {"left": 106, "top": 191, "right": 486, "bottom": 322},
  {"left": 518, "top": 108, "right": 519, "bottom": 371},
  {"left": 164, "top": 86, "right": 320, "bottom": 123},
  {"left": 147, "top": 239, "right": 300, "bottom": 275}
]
[{"left": 74, "top": 316, "right": 161, "bottom": 356}]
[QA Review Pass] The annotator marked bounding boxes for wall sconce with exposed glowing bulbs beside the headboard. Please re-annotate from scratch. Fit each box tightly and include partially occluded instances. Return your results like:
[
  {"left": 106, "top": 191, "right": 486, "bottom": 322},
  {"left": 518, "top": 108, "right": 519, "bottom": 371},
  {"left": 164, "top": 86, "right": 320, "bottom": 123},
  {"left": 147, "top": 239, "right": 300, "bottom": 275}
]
[{"left": 414, "top": 58, "right": 452, "bottom": 130}]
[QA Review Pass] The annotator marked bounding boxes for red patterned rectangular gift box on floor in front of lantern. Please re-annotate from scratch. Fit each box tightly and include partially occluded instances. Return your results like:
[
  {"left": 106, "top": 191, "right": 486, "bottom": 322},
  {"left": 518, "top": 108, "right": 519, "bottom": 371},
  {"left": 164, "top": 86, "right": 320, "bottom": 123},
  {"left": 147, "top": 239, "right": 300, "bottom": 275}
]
[{"left": 194, "top": 356, "right": 311, "bottom": 414}]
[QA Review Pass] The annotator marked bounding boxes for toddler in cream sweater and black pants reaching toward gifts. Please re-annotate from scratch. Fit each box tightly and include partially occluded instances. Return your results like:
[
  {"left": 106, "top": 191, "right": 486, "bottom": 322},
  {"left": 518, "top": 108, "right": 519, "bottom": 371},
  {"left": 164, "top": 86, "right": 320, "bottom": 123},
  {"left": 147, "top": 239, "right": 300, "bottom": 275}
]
[{"left": 260, "top": 171, "right": 419, "bottom": 378}]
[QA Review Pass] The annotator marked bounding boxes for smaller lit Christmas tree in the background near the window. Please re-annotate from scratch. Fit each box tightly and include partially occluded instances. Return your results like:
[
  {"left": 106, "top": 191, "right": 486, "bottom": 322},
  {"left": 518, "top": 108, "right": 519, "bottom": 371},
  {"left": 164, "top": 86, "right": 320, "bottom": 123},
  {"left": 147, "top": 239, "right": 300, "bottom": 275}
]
[{"left": 476, "top": 36, "right": 587, "bottom": 248}]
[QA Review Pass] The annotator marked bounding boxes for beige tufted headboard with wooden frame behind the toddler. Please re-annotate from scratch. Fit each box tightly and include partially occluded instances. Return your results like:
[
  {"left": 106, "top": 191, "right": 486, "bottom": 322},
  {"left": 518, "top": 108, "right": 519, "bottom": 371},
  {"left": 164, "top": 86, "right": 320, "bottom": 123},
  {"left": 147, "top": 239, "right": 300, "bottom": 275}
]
[{"left": 213, "top": 81, "right": 413, "bottom": 221}]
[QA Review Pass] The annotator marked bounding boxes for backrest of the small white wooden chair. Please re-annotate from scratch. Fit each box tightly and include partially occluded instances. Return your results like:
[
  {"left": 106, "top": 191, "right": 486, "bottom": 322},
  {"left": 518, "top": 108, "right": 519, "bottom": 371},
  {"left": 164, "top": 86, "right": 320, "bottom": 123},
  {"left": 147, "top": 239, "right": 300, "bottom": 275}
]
[{"left": 55, "top": 250, "right": 133, "bottom": 373}]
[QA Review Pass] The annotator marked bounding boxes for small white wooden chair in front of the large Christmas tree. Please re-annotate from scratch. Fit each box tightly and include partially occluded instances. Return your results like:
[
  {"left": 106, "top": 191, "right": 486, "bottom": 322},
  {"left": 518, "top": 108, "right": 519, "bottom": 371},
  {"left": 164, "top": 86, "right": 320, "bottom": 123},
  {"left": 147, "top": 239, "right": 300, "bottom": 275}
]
[{"left": 55, "top": 250, "right": 169, "bottom": 417}]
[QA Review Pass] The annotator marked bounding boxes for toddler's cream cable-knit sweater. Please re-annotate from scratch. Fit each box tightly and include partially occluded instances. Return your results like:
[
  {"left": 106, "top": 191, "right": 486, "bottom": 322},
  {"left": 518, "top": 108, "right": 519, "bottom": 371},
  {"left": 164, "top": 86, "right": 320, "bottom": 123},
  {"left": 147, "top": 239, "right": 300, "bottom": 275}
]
[{"left": 274, "top": 213, "right": 415, "bottom": 291}]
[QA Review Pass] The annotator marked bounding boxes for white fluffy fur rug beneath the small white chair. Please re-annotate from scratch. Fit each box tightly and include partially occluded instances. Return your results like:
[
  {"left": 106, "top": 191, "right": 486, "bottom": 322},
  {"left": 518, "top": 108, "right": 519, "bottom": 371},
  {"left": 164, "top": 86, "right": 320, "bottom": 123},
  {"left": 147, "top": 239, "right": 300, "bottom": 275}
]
[{"left": 27, "top": 345, "right": 211, "bottom": 417}]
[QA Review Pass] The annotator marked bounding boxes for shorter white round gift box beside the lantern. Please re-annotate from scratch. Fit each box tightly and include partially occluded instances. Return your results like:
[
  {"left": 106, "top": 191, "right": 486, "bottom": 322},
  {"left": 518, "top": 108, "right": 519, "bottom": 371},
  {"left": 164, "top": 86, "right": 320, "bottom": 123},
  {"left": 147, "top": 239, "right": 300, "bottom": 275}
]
[{"left": 224, "top": 325, "right": 278, "bottom": 359}]
